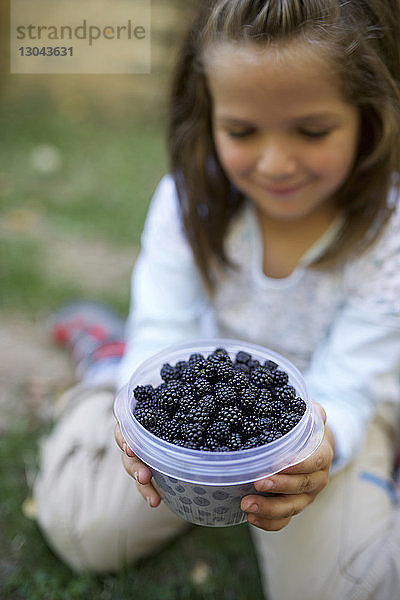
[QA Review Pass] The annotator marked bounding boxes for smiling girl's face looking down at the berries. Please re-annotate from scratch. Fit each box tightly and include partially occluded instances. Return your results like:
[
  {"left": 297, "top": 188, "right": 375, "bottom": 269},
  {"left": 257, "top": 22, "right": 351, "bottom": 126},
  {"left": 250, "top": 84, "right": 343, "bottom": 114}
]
[{"left": 207, "top": 42, "right": 359, "bottom": 220}]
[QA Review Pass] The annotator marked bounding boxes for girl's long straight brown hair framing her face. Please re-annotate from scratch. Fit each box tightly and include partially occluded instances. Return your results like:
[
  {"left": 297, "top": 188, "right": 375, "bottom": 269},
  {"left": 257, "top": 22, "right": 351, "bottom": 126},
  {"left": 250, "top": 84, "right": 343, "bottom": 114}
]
[{"left": 168, "top": 0, "right": 400, "bottom": 289}]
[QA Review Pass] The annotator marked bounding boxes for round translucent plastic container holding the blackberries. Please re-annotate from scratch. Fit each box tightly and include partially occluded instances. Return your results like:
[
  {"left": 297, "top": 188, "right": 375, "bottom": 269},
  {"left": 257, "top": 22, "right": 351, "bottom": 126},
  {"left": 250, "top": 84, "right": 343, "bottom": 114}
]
[{"left": 114, "top": 338, "right": 324, "bottom": 527}]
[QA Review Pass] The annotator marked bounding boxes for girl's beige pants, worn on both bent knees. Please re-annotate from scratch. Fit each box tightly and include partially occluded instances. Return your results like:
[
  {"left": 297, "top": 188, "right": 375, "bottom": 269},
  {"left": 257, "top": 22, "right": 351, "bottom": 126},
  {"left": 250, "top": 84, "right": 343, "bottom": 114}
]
[{"left": 34, "top": 385, "right": 400, "bottom": 600}]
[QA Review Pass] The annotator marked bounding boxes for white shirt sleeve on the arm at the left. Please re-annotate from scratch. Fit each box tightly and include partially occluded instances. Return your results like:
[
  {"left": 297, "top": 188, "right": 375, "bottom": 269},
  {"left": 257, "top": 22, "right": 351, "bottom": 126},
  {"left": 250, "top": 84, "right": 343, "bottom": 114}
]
[{"left": 118, "top": 176, "right": 211, "bottom": 385}]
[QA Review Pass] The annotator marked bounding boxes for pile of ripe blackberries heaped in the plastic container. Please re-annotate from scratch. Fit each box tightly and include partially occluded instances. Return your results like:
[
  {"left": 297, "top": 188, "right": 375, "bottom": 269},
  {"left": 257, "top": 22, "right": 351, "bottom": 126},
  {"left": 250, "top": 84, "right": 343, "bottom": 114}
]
[{"left": 133, "top": 348, "right": 306, "bottom": 452}]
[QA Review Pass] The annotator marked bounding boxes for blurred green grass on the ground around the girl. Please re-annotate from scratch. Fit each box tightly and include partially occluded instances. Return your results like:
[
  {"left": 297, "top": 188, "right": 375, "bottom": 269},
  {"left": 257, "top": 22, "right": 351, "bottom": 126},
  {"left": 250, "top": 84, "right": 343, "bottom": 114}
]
[{"left": 0, "top": 91, "right": 263, "bottom": 600}]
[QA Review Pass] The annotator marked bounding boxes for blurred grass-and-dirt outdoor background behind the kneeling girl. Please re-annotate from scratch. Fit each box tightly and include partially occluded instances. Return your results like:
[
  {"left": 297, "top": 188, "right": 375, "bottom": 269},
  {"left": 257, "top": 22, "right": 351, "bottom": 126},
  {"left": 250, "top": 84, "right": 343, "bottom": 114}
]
[{"left": 0, "top": 0, "right": 262, "bottom": 600}]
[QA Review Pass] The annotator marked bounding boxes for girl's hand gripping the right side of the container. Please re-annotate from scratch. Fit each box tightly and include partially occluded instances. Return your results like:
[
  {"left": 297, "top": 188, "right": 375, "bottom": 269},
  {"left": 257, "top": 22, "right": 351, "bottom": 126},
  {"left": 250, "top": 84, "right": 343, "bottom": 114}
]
[{"left": 241, "top": 405, "right": 334, "bottom": 531}]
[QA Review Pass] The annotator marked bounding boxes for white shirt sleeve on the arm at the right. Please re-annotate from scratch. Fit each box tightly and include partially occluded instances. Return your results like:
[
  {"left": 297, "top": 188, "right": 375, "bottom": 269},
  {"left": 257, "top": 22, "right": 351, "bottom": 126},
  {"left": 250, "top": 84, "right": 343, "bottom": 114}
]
[{"left": 306, "top": 205, "right": 400, "bottom": 469}]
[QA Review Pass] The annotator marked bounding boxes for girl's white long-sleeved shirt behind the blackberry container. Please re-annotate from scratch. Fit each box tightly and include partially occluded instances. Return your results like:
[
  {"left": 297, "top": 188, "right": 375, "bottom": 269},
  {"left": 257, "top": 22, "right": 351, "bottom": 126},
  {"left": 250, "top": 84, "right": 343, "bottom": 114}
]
[{"left": 119, "top": 176, "right": 400, "bottom": 468}]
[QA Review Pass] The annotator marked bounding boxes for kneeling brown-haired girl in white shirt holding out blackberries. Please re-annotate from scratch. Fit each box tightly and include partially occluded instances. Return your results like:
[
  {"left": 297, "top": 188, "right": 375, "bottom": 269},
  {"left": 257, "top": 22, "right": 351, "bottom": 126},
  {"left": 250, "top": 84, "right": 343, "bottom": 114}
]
[{"left": 35, "top": 0, "right": 400, "bottom": 600}]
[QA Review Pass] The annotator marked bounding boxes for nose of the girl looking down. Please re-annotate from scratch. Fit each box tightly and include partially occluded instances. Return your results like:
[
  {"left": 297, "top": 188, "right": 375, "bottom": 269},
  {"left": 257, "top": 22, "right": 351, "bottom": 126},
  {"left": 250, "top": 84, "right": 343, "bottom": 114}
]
[{"left": 257, "top": 139, "right": 296, "bottom": 180}]
